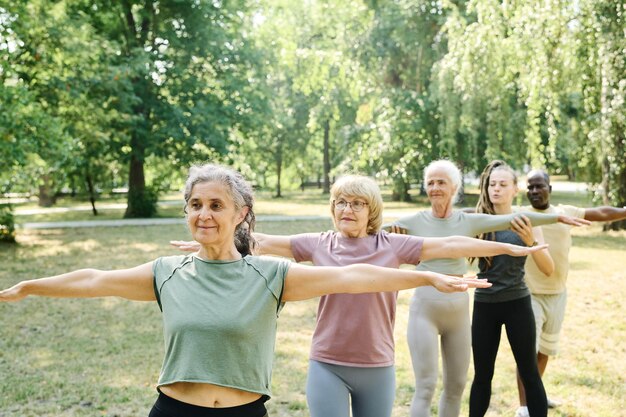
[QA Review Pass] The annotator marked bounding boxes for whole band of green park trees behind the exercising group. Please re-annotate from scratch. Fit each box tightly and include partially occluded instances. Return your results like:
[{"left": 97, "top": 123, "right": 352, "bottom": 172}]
[{"left": 0, "top": 0, "right": 626, "bottom": 228}]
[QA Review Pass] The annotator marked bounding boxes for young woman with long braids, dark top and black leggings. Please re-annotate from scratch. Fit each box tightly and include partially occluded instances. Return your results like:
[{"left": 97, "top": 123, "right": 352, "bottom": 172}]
[{"left": 469, "top": 160, "right": 554, "bottom": 417}]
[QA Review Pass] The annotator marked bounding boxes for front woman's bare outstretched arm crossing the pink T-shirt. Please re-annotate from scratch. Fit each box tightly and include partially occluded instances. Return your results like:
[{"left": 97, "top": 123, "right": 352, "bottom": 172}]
[{"left": 282, "top": 263, "right": 491, "bottom": 301}]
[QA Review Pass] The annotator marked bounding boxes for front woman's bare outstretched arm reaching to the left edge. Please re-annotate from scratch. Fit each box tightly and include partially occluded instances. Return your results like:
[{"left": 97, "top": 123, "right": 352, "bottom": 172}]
[{"left": 0, "top": 262, "right": 156, "bottom": 301}]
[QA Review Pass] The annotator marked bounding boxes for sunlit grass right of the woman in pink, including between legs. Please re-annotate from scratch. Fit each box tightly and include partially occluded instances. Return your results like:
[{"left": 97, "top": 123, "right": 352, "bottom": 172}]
[{"left": 394, "top": 225, "right": 626, "bottom": 417}]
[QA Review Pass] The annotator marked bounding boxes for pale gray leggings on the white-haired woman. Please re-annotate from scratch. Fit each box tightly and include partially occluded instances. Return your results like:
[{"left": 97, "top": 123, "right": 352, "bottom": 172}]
[{"left": 407, "top": 287, "right": 471, "bottom": 417}]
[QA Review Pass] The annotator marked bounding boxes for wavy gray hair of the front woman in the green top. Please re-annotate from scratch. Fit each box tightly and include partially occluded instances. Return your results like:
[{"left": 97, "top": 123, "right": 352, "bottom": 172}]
[{"left": 183, "top": 164, "right": 256, "bottom": 256}]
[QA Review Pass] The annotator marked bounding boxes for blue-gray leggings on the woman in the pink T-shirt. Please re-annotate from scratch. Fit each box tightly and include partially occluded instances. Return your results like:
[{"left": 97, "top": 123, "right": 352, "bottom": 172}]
[{"left": 306, "top": 360, "right": 396, "bottom": 417}]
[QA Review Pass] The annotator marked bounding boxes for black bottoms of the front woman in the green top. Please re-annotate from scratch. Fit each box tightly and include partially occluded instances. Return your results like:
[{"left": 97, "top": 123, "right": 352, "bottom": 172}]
[{"left": 148, "top": 392, "right": 268, "bottom": 417}]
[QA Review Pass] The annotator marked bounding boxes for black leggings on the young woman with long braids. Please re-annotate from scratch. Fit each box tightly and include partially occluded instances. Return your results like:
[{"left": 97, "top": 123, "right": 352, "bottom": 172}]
[{"left": 469, "top": 296, "right": 548, "bottom": 417}]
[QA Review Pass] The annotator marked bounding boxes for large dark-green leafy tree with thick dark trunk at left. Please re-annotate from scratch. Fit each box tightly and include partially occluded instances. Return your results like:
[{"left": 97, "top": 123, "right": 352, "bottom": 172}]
[{"left": 0, "top": 0, "right": 270, "bottom": 215}]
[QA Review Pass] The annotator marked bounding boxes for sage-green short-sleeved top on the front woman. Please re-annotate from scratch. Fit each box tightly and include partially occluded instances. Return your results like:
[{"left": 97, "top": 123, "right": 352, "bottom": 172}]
[{"left": 153, "top": 255, "right": 289, "bottom": 397}]
